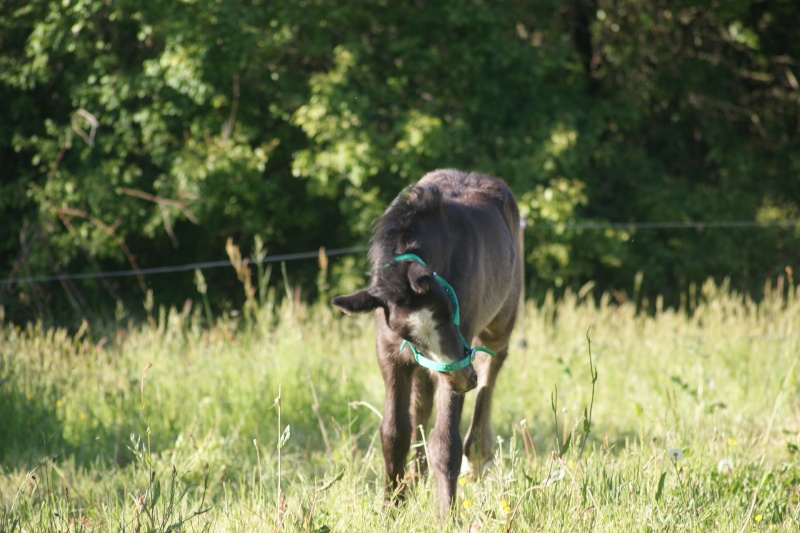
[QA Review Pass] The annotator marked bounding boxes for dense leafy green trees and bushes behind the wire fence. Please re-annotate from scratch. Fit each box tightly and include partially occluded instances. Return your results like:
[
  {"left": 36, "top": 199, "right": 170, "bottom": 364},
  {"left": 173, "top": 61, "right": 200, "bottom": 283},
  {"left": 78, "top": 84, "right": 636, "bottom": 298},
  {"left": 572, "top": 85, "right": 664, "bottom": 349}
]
[{"left": 0, "top": 0, "right": 800, "bottom": 321}]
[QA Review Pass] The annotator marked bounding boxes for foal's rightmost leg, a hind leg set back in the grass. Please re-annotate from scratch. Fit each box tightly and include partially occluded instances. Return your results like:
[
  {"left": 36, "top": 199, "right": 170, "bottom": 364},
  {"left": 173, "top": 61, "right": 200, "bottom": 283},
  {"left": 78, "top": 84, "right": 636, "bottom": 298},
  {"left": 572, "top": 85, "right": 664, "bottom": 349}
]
[{"left": 461, "top": 344, "right": 508, "bottom": 476}]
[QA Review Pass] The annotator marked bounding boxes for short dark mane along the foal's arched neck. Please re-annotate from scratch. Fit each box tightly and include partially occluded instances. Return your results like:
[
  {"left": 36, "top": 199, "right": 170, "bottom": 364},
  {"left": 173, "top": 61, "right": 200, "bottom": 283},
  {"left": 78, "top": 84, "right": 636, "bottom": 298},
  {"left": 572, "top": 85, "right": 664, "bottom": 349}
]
[{"left": 369, "top": 183, "right": 444, "bottom": 275}]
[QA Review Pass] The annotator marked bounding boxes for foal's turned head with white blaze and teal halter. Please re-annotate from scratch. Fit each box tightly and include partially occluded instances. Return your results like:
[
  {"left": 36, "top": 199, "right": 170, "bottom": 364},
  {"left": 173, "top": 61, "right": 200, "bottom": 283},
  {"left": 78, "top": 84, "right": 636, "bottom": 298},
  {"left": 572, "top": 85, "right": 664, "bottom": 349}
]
[{"left": 333, "top": 258, "right": 477, "bottom": 393}]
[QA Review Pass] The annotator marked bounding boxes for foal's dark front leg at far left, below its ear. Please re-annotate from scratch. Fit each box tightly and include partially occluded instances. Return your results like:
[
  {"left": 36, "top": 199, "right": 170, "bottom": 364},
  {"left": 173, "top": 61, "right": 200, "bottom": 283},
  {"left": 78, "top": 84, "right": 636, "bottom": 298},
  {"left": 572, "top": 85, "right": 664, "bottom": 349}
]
[{"left": 380, "top": 364, "right": 414, "bottom": 497}]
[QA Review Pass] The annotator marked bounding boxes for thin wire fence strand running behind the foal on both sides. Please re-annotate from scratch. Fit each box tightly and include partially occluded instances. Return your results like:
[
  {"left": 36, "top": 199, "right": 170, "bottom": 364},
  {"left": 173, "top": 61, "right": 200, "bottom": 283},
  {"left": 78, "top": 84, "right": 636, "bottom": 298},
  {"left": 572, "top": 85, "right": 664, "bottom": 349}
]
[{"left": 0, "top": 220, "right": 800, "bottom": 286}]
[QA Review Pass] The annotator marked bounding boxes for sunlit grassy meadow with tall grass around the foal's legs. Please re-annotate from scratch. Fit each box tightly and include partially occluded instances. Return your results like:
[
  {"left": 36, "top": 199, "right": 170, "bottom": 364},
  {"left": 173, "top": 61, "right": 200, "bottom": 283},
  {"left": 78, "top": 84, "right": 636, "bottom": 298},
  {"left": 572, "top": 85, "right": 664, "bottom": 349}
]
[{"left": 0, "top": 276, "right": 800, "bottom": 532}]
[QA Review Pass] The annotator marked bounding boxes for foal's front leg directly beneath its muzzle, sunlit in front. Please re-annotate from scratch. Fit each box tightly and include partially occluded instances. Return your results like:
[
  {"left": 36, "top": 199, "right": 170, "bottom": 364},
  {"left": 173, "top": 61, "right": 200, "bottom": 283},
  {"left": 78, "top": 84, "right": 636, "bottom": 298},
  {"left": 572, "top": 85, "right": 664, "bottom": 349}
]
[{"left": 428, "top": 379, "right": 464, "bottom": 515}]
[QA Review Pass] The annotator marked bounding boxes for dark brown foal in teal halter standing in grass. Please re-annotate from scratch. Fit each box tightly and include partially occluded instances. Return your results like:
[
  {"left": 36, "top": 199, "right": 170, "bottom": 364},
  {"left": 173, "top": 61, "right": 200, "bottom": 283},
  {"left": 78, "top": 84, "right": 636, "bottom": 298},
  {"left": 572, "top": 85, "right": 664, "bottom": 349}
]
[{"left": 333, "top": 170, "right": 522, "bottom": 513}]
